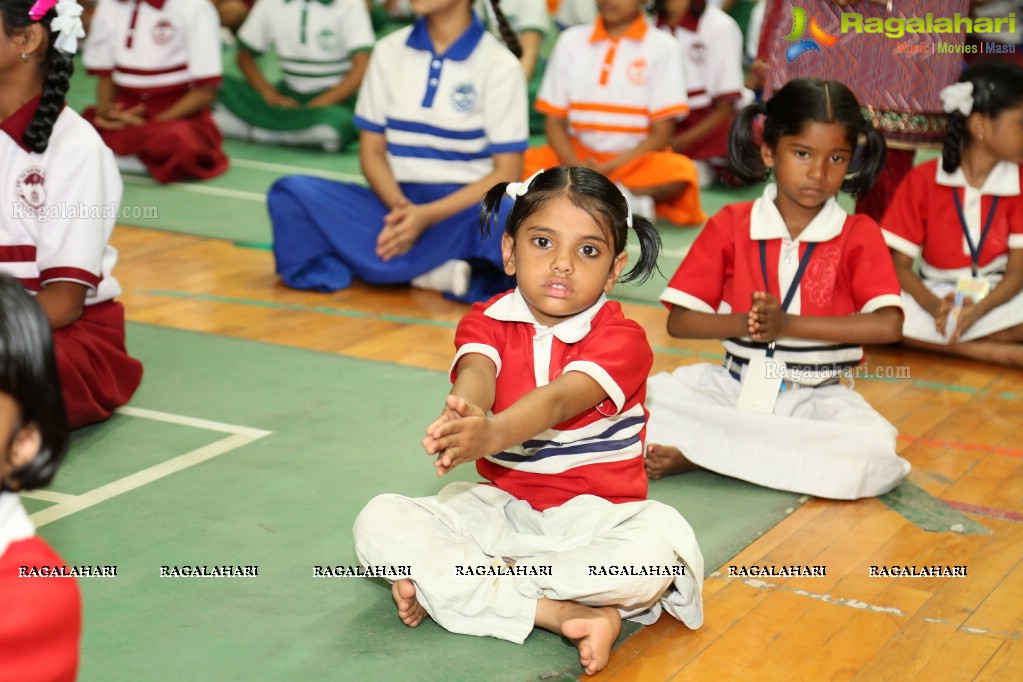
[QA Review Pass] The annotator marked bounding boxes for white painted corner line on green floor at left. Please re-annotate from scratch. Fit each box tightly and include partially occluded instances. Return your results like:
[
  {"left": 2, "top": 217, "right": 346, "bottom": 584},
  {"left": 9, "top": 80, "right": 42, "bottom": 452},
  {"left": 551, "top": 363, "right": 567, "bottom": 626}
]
[{"left": 21, "top": 407, "right": 273, "bottom": 528}]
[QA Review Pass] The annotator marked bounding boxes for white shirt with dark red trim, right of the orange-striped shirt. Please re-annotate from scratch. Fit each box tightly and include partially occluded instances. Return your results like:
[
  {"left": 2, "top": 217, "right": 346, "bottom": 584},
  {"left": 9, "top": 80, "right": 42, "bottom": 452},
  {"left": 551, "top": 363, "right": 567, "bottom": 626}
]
[{"left": 666, "top": 5, "right": 744, "bottom": 110}]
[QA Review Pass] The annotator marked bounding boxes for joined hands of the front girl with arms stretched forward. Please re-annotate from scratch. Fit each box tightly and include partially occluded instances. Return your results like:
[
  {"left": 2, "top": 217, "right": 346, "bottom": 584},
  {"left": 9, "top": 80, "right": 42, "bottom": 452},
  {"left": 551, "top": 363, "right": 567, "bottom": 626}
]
[{"left": 422, "top": 396, "right": 493, "bottom": 475}]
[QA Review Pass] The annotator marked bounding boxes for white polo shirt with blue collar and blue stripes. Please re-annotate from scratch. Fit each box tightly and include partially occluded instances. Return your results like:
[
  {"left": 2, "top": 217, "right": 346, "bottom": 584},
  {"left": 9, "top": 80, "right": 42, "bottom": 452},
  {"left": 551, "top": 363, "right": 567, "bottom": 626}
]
[{"left": 355, "top": 17, "right": 529, "bottom": 184}]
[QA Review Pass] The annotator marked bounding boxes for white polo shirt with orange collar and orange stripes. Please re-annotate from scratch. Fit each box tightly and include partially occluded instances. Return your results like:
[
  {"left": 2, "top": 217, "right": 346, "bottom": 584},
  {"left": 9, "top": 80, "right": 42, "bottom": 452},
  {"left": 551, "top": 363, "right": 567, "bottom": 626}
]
[{"left": 536, "top": 15, "right": 690, "bottom": 153}]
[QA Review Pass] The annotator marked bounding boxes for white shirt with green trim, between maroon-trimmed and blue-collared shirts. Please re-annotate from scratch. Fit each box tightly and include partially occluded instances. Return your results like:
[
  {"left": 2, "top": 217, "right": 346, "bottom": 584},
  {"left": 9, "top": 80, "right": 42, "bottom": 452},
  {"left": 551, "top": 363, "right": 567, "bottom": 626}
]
[{"left": 237, "top": 0, "right": 376, "bottom": 94}]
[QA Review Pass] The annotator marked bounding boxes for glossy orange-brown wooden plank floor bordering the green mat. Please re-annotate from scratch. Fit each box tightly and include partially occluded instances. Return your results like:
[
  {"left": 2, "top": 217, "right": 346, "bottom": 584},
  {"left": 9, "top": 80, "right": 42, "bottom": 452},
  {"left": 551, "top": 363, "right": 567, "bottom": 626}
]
[{"left": 113, "top": 228, "right": 1023, "bottom": 682}]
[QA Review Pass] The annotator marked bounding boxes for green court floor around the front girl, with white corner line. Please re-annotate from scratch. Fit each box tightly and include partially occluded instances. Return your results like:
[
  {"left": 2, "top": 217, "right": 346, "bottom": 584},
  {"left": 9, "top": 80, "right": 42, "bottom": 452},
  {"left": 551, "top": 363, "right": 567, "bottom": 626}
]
[{"left": 27, "top": 324, "right": 797, "bottom": 682}]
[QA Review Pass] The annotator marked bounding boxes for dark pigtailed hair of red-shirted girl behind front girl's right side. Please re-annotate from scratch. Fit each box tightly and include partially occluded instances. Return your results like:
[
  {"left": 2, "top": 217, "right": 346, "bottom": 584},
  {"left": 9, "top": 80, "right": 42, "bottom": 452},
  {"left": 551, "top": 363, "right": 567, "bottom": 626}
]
[{"left": 728, "top": 78, "right": 888, "bottom": 196}]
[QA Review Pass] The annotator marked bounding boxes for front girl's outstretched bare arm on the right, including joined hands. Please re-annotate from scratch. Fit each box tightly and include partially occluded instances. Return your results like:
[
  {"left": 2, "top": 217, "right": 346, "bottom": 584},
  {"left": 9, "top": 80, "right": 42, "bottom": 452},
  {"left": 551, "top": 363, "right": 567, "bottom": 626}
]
[{"left": 424, "top": 370, "right": 608, "bottom": 475}]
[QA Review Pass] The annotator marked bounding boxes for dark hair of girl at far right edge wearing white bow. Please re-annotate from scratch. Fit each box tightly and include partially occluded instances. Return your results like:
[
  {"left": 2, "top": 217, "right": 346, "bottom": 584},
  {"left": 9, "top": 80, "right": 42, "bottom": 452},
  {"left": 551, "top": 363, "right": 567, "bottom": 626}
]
[{"left": 941, "top": 59, "right": 1023, "bottom": 173}]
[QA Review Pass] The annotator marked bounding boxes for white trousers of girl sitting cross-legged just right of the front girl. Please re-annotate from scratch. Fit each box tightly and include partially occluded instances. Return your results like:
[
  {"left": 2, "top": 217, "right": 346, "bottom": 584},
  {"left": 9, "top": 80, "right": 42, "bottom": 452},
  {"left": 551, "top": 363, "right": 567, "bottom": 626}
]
[{"left": 647, "top": 364, "right": 909, "bottom": 500}]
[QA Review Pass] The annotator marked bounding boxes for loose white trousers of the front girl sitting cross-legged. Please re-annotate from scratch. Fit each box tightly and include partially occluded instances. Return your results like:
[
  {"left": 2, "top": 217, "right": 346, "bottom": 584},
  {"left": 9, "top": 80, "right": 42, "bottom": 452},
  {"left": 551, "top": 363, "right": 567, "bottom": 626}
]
[{"left": 354, "top": 483, "right": 703, "bottom": 643}]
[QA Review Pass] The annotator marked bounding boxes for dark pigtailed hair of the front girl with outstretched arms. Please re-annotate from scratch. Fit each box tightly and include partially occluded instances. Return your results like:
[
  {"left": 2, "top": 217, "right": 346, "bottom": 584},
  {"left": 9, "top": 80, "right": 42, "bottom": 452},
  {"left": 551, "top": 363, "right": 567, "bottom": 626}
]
[{"left": 480, "top": 166, "right": 661, "bottom": 283}]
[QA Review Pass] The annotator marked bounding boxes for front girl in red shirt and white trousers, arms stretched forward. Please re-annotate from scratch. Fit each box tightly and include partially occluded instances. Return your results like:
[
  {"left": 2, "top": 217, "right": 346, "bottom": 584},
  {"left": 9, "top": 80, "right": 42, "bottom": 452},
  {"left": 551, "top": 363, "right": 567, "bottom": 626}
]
[{"left": 355, "top": 167, "right": 703, "bottom": 675}]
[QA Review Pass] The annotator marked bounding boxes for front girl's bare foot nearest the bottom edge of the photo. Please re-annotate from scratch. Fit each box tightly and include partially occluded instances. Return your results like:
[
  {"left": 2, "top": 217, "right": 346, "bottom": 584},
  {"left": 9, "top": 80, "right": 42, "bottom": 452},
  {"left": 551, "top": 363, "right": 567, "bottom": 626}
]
[{"left": 536, "top": 598, "right": 622, "bottom": 675}]
